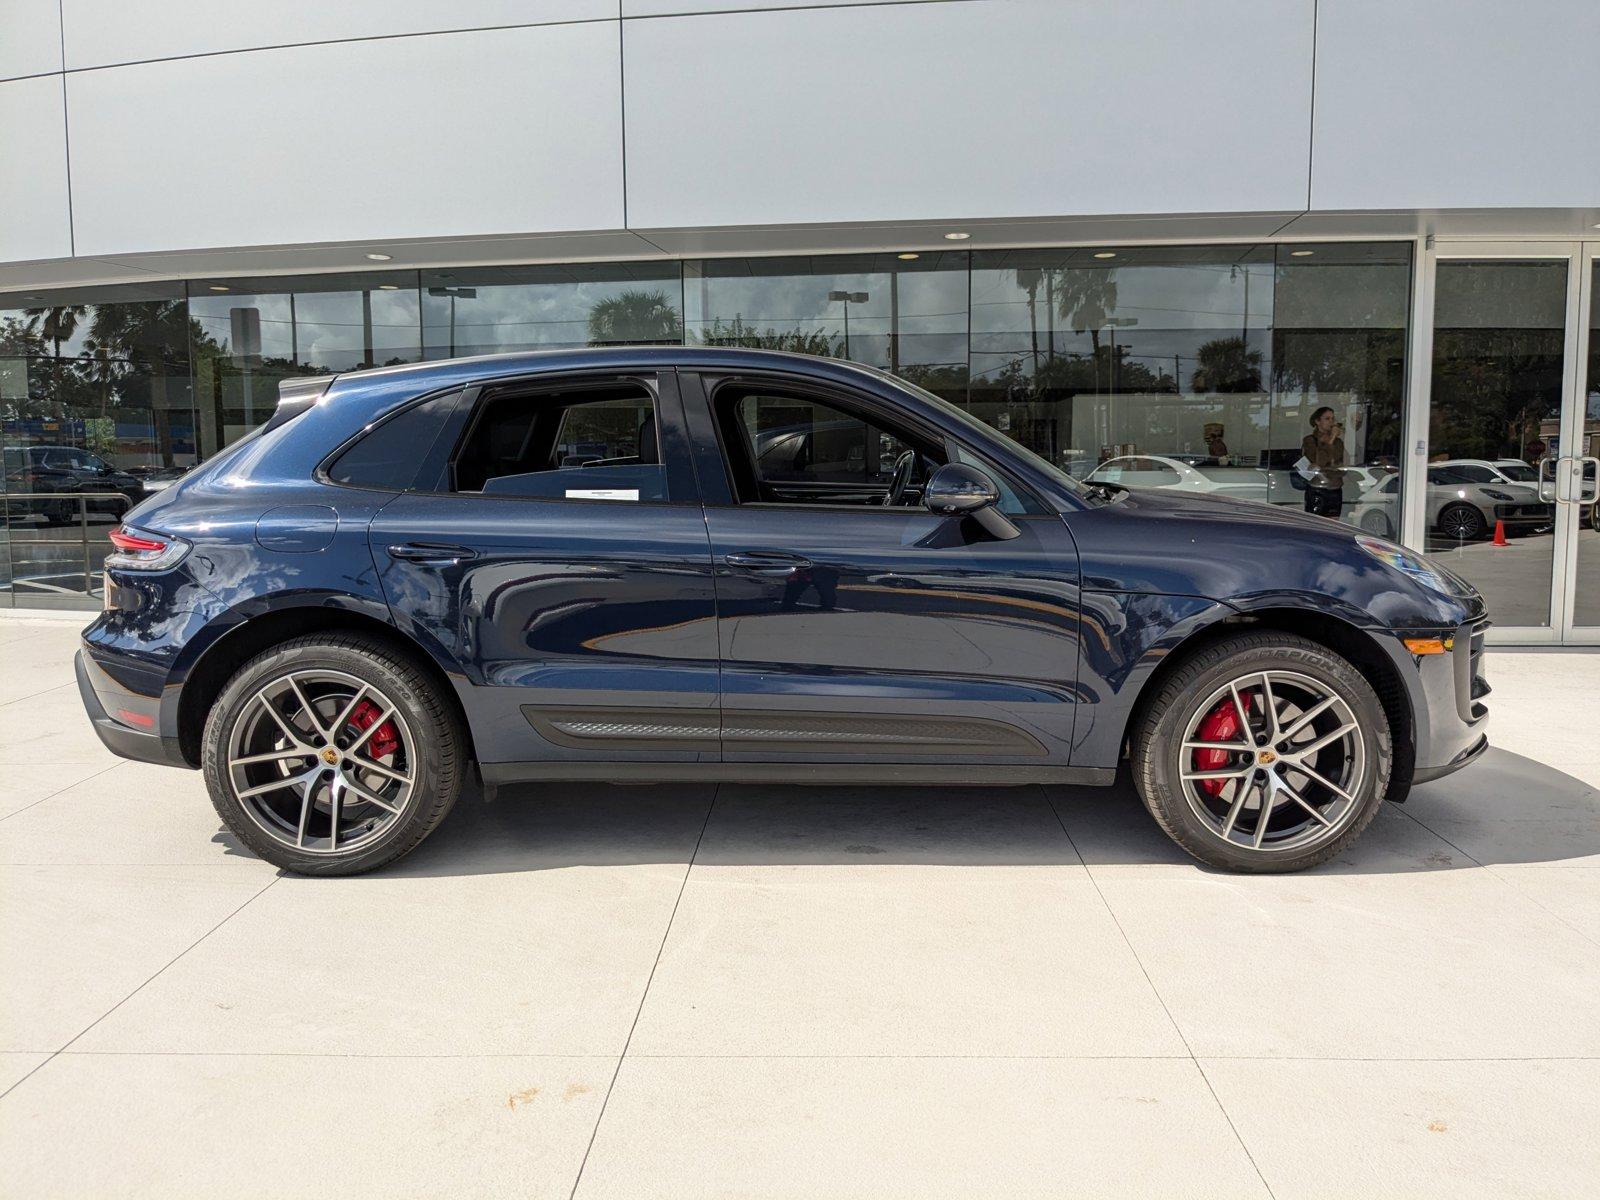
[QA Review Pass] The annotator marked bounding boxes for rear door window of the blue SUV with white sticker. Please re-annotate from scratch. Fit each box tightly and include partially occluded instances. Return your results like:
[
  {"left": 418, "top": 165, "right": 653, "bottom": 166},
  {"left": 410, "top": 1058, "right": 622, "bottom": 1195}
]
[{"left": 453, "top": 381, "right": 667, "bottom": 501}]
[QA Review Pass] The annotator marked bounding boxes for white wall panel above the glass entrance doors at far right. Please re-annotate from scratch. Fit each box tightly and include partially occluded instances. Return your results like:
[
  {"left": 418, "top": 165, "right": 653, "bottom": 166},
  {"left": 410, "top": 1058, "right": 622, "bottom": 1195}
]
[{"left": 1312, "top": 0, "right": 1600, "bottom": 210}]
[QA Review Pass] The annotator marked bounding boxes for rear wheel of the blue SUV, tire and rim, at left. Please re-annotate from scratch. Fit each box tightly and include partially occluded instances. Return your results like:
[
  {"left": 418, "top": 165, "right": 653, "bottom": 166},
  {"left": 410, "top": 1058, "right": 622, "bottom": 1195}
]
[{"left": 203, "top": 635, "right": 466, "bottom": 875}]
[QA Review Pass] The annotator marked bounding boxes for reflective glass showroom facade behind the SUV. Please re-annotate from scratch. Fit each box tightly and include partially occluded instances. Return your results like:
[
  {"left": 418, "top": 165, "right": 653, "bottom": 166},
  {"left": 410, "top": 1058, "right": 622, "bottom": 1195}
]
[{"left": 0, "top": 242, "right": 1600, "bottom": 640}]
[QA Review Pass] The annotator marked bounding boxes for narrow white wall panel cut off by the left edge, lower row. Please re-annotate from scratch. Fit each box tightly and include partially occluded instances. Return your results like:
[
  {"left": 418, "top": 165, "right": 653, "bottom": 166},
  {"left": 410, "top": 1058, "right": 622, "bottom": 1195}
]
[{"left": 0, "top": 75, "right": 72, "bottom": 262}]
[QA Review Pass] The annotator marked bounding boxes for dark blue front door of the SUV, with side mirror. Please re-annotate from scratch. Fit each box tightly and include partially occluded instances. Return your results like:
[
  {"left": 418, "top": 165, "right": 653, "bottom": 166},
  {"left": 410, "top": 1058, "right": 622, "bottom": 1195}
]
[{"left": 683, "top": 376, "right": 1078, "bottom": 778}]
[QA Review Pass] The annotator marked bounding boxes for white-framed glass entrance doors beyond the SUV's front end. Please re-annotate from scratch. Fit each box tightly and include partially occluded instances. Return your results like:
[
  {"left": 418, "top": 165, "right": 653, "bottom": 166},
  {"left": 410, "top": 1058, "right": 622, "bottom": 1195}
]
[{"left": 1422, "top": 243, "right": 1600, "bottom": 643}]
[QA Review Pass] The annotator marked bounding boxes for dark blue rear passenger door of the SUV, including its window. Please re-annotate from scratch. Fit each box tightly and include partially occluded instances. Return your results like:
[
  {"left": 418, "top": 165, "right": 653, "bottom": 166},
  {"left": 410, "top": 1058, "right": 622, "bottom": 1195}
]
[{"left": 370, "top": 370, "right": 718, "bottom": 778}]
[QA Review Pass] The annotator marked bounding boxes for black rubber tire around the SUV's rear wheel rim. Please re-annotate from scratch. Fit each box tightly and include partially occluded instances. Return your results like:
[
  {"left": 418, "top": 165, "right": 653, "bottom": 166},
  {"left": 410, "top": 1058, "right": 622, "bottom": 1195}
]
[{"left": 202, "top": 634, "right": 467, "bottom": 875}]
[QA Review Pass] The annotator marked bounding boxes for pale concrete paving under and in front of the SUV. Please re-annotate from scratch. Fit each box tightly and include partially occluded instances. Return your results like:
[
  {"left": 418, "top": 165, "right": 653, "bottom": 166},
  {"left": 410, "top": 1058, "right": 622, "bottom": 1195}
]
[{"left": 0, "top": 616, "right": 1600, "bottom": 1200}]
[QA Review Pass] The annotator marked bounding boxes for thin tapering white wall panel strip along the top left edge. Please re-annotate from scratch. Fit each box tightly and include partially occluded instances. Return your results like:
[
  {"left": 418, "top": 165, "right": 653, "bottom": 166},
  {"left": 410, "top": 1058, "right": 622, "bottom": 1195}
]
[{"left": 62, "top": 0, "right": 618, "bottom": 69}]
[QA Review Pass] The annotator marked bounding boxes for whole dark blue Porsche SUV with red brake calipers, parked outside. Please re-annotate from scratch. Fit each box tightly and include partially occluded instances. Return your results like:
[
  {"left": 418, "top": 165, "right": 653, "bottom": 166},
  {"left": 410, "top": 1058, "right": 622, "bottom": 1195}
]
[{"left": 77, "top": 347, "right": 1488, "bottom": 875}]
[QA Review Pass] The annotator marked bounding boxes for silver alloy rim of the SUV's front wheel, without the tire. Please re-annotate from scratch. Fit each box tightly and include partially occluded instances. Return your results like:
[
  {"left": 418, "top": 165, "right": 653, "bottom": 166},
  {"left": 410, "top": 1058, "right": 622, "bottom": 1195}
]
[{"left": 1178, "top": 670, "right": 1368, "bottom": 853}]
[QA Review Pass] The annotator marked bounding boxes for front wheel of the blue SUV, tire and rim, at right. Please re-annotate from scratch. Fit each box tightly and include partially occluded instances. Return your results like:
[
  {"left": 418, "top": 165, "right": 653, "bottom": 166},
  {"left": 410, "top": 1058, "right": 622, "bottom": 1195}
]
[{"left": 1133, "top": 632, "right": 1392, "bottom": 872}]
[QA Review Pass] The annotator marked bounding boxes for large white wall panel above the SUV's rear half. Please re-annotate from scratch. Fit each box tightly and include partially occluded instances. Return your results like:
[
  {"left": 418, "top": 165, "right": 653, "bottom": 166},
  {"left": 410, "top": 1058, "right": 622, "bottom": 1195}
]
[{"left": 67, "top": 22, "right": 622, "bottom": 254}]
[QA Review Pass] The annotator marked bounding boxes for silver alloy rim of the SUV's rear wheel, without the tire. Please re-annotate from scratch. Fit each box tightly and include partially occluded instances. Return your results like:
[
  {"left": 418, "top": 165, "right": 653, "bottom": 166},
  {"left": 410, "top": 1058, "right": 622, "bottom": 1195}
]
[{"left": 227, "top": 669, "right": 416, "bottom": 854}]
